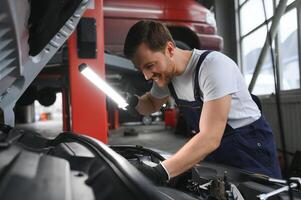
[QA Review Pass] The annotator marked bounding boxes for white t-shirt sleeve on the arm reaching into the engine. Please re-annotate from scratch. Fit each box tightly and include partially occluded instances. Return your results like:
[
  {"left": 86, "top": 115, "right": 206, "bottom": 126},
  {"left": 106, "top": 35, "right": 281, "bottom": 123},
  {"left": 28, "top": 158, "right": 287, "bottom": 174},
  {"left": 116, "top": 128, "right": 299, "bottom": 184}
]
[{"left": 199, "top": 52, "right": 240, "bottom": 102}]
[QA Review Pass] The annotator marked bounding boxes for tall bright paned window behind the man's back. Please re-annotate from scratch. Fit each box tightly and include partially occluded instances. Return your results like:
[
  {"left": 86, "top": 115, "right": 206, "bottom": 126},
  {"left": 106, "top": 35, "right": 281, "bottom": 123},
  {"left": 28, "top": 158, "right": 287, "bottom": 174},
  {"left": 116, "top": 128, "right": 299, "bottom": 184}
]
[{"left": 237, "top": 0, "right": 300, "bottom": 95}]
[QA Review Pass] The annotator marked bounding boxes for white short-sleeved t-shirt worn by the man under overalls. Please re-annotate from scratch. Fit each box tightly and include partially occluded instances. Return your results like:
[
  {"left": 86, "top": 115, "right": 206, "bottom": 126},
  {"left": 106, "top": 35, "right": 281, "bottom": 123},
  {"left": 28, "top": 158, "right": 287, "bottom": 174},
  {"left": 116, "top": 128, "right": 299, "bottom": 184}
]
[{"left": 151, "top": 49, "right": 261, "bottom": 128}]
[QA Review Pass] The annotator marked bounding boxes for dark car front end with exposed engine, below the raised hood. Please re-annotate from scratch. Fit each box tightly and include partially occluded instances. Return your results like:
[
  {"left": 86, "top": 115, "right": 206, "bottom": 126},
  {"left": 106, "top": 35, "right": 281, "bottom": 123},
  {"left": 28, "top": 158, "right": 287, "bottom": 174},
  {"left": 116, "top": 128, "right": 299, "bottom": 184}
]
[{"left": 0, "top": 125, "right": 301, "bottom": 200}]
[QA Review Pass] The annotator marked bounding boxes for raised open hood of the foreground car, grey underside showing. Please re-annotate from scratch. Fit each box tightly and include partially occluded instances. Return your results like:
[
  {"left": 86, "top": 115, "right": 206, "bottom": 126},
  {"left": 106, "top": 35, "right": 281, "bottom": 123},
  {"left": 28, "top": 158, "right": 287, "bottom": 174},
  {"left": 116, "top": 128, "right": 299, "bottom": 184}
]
[{"left": 0, "top": 0, "right": 89, "bottom": 125}]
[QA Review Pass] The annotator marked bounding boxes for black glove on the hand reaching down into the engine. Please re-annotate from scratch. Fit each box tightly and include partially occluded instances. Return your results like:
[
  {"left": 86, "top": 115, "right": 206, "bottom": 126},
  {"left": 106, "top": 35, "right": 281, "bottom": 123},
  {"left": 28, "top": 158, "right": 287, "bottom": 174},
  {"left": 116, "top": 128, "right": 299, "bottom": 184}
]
[{"left": 137, "top": 162, "right": 169, "bottom": 185}]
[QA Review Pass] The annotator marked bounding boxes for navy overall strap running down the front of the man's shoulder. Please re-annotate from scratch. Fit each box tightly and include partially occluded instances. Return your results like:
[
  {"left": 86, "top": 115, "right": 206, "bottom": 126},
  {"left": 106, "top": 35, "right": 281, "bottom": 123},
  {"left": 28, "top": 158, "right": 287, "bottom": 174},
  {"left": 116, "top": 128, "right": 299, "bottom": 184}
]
[{"left": 193, "top": 50, "right": 212, "bottom": 101}]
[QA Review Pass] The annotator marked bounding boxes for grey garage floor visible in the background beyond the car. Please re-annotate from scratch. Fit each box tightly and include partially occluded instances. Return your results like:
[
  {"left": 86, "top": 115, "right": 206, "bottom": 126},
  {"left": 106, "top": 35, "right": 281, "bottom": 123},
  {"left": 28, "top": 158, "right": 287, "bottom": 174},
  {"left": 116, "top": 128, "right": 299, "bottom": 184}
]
[{"left": 16, "top": 120, "right": 189, "bottom": 153}]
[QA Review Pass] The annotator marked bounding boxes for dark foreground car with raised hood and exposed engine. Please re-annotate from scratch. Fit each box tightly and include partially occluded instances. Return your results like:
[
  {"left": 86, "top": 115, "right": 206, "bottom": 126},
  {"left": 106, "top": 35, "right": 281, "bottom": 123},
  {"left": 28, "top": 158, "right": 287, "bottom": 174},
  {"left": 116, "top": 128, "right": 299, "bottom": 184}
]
[{"left": 0, "top": 0, "right": 301, "bottom": 200}]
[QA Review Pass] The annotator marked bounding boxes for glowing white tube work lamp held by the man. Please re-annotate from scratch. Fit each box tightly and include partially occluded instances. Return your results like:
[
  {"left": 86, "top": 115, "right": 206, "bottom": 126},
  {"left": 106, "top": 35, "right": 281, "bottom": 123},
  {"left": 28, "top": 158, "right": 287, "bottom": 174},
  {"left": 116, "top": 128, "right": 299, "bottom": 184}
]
[{"left": 78, "top": 64, "right": 129, "bottom": 110}]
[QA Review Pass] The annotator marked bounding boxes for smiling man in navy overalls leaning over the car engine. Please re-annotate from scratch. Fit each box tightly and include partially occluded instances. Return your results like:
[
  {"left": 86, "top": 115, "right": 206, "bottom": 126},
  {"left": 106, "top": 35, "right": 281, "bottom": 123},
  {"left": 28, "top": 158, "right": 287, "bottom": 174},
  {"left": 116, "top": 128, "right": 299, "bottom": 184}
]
[{"left": 124, "top": 21, "right": 281, "bottom": 183}]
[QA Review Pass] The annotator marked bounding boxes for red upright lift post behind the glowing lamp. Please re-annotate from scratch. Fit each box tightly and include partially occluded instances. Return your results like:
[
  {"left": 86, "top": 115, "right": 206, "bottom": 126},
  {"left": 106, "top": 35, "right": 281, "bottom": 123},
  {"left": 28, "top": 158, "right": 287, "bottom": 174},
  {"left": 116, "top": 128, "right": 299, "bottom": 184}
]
[{"left": 64, "top": 0, "right": 108, "bottom": 143}]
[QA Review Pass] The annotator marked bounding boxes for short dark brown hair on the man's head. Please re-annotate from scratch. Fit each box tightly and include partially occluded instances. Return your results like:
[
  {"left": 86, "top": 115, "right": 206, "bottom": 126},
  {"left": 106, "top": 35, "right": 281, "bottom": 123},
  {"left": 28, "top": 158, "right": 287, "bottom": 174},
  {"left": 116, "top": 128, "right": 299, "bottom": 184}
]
[{"left": 123, "top": 20, "right": 175, "bottom": 59}]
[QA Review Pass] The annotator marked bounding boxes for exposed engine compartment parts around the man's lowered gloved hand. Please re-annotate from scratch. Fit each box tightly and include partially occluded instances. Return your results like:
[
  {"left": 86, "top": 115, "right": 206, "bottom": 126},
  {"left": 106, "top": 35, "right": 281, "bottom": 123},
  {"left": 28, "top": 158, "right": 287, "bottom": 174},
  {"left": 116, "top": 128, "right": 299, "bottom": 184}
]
[{"left": 111, "top": 146, "right": 301, "bottom": 200}]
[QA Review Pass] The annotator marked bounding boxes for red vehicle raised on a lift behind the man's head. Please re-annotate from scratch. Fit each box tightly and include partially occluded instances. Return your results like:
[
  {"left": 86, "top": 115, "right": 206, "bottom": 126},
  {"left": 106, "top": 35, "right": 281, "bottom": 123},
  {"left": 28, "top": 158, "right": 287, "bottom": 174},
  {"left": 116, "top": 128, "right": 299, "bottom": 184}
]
[{"left": 104, "top": 0, "right": 223, "bottom": 54}]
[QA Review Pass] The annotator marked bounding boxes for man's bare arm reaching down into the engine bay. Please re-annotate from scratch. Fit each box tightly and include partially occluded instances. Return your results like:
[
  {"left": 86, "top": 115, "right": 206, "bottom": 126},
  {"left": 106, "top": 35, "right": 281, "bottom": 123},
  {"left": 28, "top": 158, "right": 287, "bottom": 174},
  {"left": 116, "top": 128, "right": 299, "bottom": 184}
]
[{"left": 162, "top": 95, "right": 231, "bottom": 177}]
